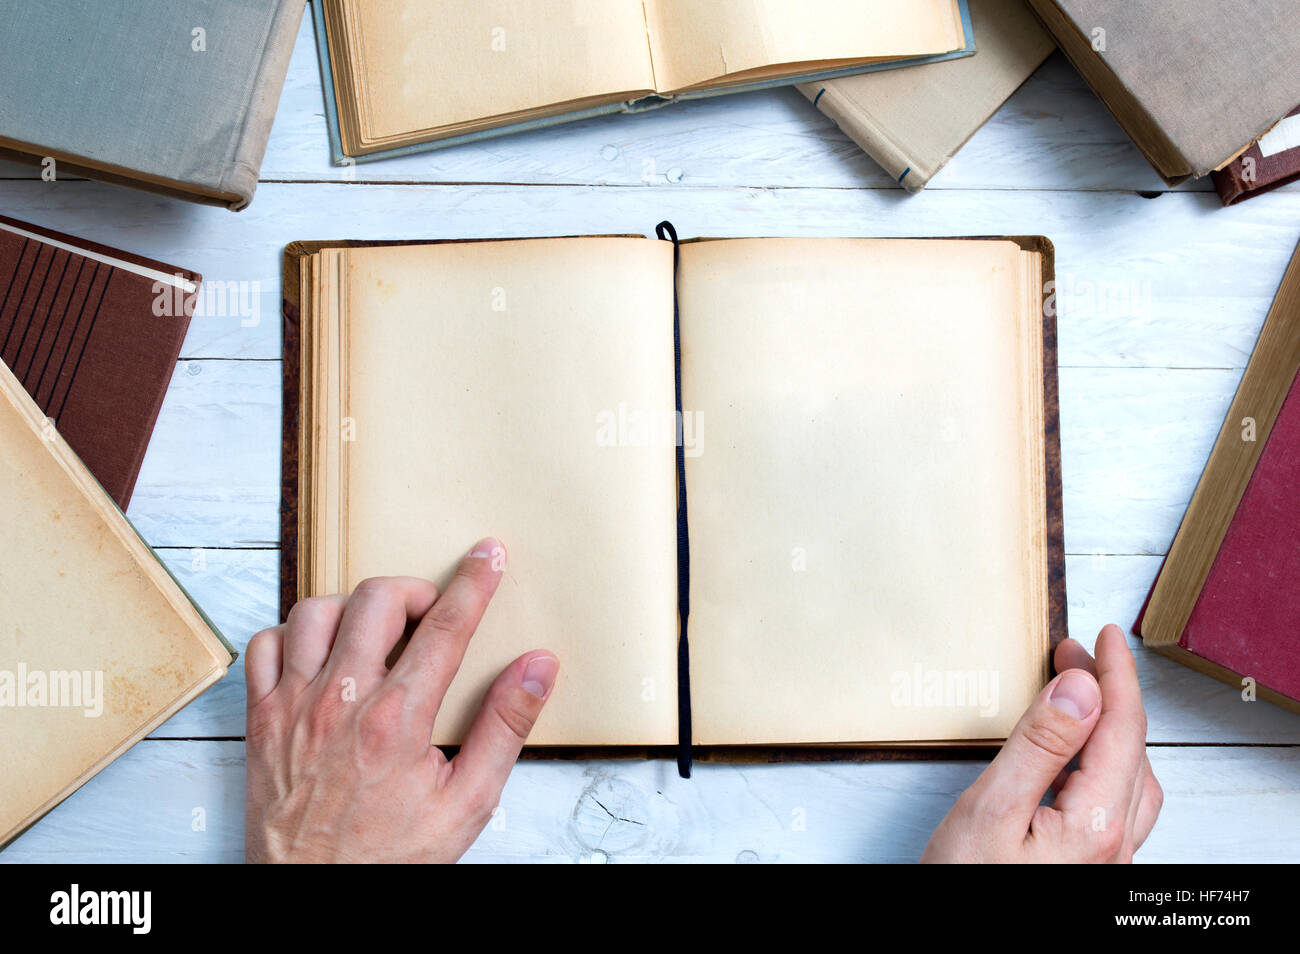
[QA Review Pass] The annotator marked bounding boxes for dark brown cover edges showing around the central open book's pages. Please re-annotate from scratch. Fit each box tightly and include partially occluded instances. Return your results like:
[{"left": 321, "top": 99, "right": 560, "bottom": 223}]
[{"left": 280, "top": 235, "right": 1069, "bottom": 763}]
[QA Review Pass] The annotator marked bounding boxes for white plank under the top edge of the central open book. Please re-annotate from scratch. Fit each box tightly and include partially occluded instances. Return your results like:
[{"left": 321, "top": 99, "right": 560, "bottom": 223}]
[{"left": 0, "top": 181, "right": 1300, "bottom": 368}]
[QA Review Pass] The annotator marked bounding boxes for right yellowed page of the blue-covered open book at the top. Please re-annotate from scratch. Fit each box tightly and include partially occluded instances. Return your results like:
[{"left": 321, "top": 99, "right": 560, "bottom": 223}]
[{"left": 646, "top": 0, "right": 965, "bottom": 92}]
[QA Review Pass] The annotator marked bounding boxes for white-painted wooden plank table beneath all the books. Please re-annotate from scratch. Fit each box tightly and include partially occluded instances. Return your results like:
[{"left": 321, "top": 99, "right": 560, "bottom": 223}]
[{"left": 0, "top": 3, "right": 1300, "bottom": 862}]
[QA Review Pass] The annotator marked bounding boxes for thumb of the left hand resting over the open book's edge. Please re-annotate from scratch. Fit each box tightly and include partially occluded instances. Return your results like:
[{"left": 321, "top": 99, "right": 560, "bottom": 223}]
[{"left": 451, "top": 651, "right": 560, "bottom": 807}]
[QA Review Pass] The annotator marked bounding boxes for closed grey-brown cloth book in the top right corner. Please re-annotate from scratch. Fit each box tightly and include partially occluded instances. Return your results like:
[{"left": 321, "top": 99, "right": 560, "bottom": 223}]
[{"left": 1030, "top": 0, "right": 1300, "bottom": 185}]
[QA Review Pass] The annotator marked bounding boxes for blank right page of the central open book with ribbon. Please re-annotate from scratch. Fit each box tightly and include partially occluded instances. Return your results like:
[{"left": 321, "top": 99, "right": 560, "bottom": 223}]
[{"left": 680, "top": 239, "right": 1048, "bottom": 743}]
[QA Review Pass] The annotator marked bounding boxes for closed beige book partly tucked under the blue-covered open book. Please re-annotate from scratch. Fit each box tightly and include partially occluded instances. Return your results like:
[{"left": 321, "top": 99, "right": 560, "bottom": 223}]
[{"left": 798, "top": 0, "right": 1056, "bottom": 192}]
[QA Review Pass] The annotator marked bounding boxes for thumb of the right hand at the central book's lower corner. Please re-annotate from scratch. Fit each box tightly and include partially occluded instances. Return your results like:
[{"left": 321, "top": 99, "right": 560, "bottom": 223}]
[{"left": 969, "top": 669, "right": 1101, "bottom": 831}]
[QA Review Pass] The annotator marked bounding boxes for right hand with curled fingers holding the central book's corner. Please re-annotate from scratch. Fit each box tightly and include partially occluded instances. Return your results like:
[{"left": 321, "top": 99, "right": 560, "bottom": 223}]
[{"left": 920, "top": 624, "right": 1164, "bottom": 863}]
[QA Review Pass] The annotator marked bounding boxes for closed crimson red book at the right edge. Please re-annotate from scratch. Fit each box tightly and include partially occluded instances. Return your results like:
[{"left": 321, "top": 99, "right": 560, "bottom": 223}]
[{"left": 1134, "top": 239, "right": 1300, "bottom": 712}]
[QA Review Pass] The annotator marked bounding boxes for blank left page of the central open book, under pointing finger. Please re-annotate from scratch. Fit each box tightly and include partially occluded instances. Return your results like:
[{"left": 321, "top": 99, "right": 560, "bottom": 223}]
[{"left": 343, "top": 238, "right": 677, "bottom": 745}]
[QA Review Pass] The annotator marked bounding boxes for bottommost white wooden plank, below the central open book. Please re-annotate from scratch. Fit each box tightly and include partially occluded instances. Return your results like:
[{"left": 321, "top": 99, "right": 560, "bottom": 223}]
[{"left": 0, "top": 741, "right": 1300, "bottom": 863}]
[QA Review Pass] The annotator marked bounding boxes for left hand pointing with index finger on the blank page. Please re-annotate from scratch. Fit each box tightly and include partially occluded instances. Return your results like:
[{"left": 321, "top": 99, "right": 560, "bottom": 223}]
[{"left": 244, "top": 539, "right": 559, "bottom": 862}]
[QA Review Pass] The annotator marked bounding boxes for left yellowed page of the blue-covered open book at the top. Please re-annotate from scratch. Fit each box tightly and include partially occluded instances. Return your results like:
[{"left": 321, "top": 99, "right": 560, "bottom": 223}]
[{"left": 341, "top": 0, "right": 654, "bottom": 142}]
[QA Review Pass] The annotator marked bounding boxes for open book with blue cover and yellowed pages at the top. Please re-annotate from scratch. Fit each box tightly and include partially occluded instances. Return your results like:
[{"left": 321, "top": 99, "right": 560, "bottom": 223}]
[{"left": 313, "top": 0, "right": 974, "bottom": 162}]
